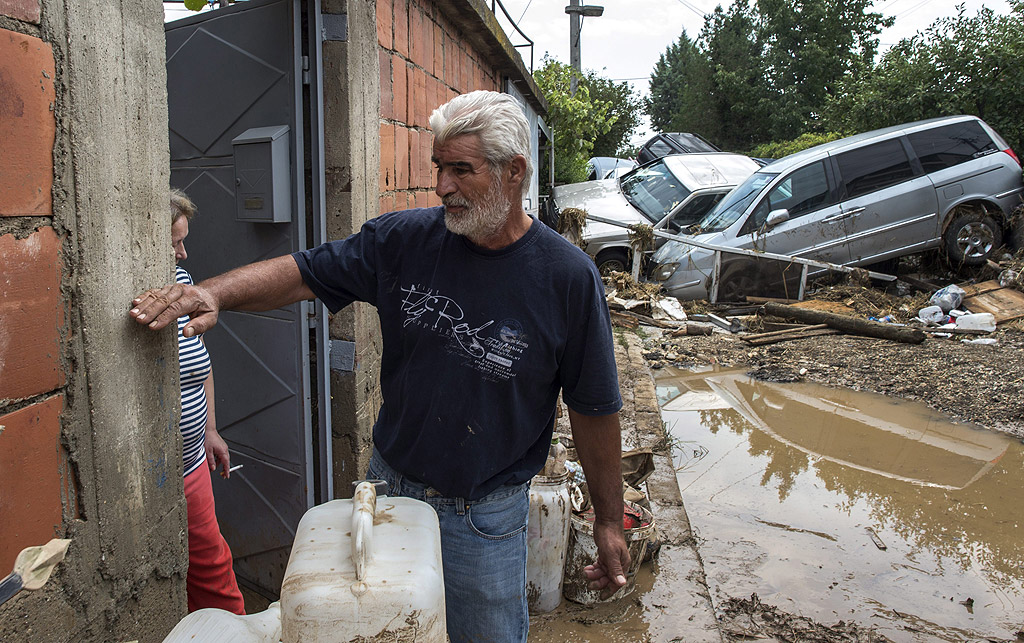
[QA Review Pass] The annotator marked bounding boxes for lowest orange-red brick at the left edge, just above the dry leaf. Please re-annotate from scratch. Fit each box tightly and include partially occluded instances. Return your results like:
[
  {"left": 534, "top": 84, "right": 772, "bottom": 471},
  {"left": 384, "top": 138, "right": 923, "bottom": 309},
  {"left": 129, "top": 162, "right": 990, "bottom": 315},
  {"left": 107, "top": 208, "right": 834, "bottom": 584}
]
[{"left": 0, "top": 395, "right": 63, "bottom": 573}]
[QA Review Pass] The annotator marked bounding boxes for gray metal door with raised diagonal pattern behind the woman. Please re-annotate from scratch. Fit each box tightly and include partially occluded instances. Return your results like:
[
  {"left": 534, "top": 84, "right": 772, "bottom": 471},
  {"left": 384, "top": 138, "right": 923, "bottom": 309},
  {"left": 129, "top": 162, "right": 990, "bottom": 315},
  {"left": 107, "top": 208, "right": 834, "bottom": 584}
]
[{"left": 165, "top": 0, "right": 332, "bottom": 597}]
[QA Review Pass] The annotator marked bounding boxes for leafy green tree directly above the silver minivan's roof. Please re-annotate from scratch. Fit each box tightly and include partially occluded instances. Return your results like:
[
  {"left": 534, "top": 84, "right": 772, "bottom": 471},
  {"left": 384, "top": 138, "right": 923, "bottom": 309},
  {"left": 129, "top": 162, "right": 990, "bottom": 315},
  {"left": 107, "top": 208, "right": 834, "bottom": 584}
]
[{"left": 826, "top": 0, "right": 1024, "bottom": 148}]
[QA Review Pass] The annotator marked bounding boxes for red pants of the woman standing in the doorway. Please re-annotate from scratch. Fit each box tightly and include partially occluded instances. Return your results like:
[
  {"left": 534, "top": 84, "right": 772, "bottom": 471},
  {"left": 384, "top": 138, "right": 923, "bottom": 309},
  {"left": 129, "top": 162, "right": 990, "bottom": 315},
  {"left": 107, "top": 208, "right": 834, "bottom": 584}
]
[{"left": 184, "top": 463, "right": 246, "bottom": 614}]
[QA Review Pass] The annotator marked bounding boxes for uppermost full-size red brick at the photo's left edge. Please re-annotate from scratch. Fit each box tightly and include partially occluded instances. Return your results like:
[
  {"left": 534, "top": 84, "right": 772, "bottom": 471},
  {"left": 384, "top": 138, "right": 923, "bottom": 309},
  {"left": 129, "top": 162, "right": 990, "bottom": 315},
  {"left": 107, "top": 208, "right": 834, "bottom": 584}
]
[{"left": 0, "top": 28, "right": 56, "bottom": 216}]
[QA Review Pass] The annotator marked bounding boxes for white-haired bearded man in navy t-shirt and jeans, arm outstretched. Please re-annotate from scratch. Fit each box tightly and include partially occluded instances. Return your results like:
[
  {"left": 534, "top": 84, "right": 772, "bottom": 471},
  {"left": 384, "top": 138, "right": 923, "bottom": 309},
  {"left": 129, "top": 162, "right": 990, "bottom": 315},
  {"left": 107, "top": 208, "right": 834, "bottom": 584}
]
[{"left": 130, "top": 91, "right": 629, "bottom": 642}]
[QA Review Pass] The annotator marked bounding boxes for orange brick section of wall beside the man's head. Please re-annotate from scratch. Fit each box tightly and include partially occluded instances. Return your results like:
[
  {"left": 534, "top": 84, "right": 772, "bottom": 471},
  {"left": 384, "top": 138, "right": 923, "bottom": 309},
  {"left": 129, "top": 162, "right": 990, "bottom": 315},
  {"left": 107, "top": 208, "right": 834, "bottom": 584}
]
[{"left": 377, "top": 0, "right": 500, "bottom": 212}]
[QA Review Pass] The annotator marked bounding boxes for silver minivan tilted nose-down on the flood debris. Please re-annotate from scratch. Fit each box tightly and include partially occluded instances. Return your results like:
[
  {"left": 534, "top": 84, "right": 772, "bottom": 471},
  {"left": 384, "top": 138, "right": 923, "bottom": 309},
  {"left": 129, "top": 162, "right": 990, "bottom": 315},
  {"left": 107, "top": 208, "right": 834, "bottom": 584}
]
[{"left": 650, "top": 116, "right": 1024, "bottom": 301}]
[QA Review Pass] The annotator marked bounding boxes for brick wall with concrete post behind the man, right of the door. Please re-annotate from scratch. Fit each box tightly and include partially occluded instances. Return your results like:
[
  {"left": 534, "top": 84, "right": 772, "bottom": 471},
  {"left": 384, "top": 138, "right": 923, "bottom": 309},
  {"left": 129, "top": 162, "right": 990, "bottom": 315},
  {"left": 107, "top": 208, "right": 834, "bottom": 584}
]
[{"left": 324, "top": 0, "right": 545, "bottom": 496}]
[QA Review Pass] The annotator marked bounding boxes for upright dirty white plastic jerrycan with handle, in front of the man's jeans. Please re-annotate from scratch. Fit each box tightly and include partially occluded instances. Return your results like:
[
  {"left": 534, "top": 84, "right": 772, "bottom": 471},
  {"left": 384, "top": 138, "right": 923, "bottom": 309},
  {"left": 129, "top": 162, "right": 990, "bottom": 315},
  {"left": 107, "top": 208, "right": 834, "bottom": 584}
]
[{"left": 281, "top": 481, "right": 447, "bottom": 643}]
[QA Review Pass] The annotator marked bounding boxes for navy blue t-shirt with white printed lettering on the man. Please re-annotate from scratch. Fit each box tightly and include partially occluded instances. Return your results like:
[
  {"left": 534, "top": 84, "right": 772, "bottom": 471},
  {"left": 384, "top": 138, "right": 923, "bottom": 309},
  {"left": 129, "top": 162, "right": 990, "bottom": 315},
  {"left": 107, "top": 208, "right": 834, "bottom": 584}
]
[{"left": 293, "top": 207, "right": 622, "bottom": 500}]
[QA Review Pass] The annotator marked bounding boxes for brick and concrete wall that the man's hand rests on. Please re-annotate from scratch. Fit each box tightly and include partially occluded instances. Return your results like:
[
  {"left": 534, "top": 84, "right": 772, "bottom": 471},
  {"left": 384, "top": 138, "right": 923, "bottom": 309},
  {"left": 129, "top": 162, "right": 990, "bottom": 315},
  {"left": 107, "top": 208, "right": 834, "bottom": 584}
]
[{"left": 0, "top": 0, "right": 187, "bottom": 641}]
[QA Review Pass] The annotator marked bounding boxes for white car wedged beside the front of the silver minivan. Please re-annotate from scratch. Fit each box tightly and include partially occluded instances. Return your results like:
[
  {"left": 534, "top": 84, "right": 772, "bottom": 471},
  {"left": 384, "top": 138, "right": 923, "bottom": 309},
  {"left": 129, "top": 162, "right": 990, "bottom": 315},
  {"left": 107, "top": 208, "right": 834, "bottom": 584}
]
[{"left": 542, "top": 152, "right": 759, "bottom": 274}]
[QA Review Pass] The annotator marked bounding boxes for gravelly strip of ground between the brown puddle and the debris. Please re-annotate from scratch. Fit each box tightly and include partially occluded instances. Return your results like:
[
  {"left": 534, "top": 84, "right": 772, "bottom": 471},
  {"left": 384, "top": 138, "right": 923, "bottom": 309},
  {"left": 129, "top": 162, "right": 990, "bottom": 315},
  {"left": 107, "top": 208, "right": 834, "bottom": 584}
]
[{"left": 644, "top": 328, "right": 1024, "bottom": 438}]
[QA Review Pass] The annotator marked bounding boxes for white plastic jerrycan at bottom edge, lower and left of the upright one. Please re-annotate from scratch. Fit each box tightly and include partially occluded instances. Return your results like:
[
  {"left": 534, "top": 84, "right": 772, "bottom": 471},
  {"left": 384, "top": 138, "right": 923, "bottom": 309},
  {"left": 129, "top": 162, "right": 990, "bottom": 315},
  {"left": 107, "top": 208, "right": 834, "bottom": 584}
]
[{"left": 164, "top": 603, "right": 281, "bottom": 643}]
